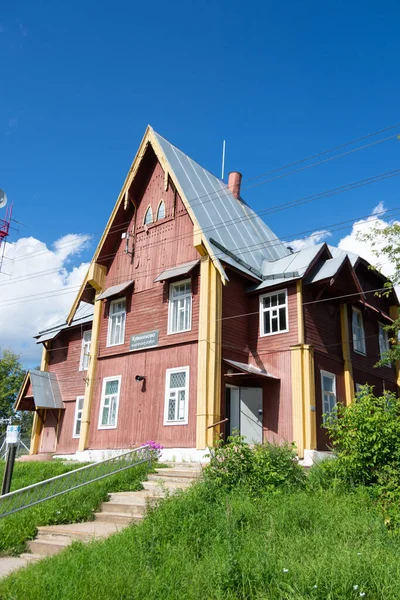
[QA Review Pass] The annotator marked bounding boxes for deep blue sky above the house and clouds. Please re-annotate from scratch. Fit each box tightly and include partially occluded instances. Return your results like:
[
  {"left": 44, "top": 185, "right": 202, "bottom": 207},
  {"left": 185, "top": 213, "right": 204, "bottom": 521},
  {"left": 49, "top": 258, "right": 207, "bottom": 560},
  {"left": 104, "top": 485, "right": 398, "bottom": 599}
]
[{"left": 0, "top": 0, "right": 400, "bottom": 364}]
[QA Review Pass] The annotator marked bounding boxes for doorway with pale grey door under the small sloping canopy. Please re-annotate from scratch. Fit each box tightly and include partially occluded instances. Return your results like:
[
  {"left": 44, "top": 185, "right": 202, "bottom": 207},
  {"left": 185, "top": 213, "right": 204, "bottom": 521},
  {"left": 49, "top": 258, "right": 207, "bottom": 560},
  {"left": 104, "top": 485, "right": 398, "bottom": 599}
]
[{"left": 225, "top": 384, "right": 263, "bottom": 444}]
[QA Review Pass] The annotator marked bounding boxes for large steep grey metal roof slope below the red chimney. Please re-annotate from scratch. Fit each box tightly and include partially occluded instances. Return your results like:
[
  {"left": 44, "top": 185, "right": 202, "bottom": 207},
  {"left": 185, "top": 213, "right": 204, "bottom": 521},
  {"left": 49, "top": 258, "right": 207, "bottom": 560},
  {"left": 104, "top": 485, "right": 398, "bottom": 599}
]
[{"left": 154, "top": 131, "right": 290, "bottom": 278}]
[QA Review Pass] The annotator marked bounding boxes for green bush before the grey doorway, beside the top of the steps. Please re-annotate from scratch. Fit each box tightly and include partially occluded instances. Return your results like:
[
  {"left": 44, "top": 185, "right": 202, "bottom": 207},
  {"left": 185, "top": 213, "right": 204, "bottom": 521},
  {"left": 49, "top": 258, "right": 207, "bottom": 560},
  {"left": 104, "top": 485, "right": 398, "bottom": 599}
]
[{"left": 205, "top": 433, "right": 305, "bottom": 496}]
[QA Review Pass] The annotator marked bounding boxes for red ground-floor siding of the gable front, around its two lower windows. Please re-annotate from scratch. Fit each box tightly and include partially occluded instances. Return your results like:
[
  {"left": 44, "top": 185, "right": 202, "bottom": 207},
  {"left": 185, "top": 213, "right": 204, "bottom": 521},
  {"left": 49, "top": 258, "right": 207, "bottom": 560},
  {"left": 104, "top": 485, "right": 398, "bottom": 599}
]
[{"left": 89, "top": 343, "right": 197, "bottom": 448}]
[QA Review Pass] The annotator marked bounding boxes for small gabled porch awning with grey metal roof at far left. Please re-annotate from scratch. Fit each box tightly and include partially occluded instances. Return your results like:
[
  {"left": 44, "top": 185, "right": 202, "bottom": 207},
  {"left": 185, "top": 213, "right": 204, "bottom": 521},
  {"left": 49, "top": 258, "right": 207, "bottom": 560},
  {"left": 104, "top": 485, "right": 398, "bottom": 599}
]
[{"left": 14, "top": 369, "right": 65, "bottom": 411}]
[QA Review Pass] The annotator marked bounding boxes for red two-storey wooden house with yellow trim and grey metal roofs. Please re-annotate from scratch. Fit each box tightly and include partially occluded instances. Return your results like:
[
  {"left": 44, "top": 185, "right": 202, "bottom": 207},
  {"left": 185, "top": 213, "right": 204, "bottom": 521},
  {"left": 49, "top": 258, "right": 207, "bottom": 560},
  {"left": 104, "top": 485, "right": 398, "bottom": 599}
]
[{"left": 16, "top": 127, "right": 398, "bottom": 460}]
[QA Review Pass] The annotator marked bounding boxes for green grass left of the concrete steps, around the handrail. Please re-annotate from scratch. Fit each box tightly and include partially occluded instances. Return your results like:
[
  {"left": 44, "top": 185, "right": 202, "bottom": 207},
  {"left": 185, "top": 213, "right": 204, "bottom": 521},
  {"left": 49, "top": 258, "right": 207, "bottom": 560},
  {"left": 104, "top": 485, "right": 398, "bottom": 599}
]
[{"left": 0, "top": 461, "right": 152, "bottom": 556}]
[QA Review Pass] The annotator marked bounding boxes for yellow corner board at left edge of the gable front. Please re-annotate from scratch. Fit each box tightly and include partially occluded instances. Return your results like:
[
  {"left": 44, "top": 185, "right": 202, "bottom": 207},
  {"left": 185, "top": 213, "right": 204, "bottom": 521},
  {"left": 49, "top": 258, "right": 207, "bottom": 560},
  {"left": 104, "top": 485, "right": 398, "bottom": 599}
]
[{"left": 78, "top": 289, "right": 103, "bottom": 452}]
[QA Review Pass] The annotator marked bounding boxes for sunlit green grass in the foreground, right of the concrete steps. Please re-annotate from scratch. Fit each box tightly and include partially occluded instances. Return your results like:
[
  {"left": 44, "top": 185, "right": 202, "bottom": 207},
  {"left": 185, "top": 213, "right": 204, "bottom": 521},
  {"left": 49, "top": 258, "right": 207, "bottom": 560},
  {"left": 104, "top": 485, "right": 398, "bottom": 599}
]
[{"left": 0, "top": 484, "right": 400, "bottom": 600}]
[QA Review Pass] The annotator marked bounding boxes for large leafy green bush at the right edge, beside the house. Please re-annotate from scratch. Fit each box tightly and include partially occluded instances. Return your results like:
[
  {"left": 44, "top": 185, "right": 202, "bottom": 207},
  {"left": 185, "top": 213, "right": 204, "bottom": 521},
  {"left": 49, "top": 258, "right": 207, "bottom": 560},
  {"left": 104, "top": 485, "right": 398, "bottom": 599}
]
[{"left": 327, "top": 386, "right": 400, "bottom": 485}]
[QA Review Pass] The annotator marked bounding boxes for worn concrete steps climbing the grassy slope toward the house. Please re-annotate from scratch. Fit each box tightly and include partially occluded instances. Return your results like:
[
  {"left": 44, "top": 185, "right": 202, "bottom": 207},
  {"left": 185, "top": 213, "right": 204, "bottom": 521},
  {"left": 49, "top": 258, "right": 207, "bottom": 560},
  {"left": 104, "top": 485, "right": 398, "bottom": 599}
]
[{"left": 9, "top": 463, "right": 202, "bottom": 576}]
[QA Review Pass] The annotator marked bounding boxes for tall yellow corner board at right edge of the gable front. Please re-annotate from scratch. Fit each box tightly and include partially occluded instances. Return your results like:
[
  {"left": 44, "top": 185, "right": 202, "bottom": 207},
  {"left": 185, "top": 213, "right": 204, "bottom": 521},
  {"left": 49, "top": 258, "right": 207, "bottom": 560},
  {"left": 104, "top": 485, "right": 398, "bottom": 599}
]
[{"left": 196, "top": 256, "right": 222, "bottom": 450}]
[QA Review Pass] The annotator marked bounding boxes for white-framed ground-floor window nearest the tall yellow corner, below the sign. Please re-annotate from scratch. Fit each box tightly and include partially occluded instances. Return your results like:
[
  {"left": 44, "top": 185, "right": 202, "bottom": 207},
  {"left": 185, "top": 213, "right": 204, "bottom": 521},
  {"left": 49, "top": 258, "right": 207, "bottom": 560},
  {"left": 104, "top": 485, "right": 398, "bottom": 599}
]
[{"left": 164, "top": 367, "right": 189, "bottom": 425}]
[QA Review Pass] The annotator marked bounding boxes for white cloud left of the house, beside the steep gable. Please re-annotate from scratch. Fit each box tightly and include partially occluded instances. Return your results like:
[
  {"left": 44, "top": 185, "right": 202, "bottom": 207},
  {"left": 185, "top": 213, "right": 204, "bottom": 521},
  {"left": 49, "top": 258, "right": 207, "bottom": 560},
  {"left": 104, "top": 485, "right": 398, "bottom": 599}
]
[{"left": 0, "top": 234, "right": 89, "bottom": 365}]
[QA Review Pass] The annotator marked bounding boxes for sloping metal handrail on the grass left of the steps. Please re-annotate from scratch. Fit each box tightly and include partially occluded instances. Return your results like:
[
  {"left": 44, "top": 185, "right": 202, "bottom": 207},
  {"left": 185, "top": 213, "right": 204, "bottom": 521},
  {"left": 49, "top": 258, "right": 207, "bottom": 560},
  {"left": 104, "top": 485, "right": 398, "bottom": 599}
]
[{"left": 0, "top": 444, "right": 153, "bottom": 518}]
